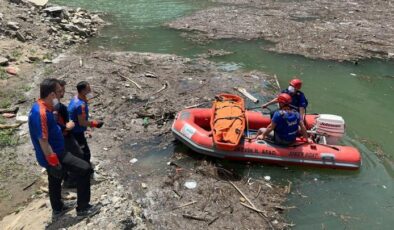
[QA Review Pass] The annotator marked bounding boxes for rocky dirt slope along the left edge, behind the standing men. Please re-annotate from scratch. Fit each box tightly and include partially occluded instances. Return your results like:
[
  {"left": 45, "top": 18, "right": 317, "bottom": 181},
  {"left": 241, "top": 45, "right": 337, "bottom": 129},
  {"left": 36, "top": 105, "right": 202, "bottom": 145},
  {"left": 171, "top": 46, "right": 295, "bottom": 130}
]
[{"left": 0, "top": 0, "right": 103, "bottom": 221}]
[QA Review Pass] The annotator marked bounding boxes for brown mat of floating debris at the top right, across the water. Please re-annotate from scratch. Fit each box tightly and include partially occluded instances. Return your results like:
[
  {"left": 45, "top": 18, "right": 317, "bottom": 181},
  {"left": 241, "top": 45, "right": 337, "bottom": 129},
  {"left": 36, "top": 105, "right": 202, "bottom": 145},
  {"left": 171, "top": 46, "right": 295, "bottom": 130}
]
[{"left": 167, "top": 0, "right": 394, "bottom": 61}]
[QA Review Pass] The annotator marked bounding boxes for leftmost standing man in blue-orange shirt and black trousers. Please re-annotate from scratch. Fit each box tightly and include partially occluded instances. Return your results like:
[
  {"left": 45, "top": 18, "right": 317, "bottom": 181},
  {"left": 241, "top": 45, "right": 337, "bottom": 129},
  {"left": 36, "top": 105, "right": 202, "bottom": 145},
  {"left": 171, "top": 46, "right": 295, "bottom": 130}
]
[{"left": 29, "top": 78, "right": 99, "bottom": 218}]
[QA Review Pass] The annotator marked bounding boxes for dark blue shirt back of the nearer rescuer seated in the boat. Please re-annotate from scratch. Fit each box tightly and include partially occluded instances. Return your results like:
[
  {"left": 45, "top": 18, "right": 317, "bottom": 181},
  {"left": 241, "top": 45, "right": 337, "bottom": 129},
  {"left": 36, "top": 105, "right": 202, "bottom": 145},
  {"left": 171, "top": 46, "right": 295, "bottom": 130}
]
[{"left": 272, "top": 110, "right": 300, "bottom": 142}]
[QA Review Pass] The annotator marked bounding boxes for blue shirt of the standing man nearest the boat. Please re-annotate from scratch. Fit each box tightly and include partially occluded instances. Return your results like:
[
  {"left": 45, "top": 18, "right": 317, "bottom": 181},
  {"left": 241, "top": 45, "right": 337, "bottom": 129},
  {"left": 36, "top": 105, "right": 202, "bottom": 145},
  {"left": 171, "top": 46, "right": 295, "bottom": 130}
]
[{"left": 67, "top": 96, "right": 89, "bottom": 133}]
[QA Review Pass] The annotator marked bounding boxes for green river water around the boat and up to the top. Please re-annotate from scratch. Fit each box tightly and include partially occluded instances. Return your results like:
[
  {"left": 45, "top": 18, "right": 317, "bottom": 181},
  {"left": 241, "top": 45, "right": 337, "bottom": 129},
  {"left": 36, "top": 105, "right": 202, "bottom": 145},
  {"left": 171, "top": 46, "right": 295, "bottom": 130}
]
[{"left": 55, "top": 0, "right": 394, "bottom": 229}]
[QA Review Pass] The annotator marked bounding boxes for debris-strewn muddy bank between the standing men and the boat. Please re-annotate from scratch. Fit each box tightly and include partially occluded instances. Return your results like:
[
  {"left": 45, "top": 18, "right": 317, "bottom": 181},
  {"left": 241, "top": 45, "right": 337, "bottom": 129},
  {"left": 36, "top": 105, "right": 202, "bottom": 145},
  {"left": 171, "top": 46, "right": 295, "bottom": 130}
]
[{"left": 2, "top": 45, "right": 290, "bottom": 229}]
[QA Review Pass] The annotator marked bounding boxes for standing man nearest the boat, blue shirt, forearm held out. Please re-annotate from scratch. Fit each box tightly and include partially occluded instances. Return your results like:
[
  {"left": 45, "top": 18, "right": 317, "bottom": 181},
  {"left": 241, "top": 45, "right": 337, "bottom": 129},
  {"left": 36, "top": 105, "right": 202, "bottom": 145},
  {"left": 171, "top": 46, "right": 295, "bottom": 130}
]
[{"left": 68, "top": 81, "right": 104, "bottom": 164}]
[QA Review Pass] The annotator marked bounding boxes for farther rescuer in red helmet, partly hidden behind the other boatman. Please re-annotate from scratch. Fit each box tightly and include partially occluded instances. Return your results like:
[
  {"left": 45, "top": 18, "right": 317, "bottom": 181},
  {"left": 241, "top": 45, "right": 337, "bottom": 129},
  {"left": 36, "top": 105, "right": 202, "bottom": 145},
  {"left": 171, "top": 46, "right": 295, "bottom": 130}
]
[{"left": 261, "top": 78, "right": 308, "bottom": 120}]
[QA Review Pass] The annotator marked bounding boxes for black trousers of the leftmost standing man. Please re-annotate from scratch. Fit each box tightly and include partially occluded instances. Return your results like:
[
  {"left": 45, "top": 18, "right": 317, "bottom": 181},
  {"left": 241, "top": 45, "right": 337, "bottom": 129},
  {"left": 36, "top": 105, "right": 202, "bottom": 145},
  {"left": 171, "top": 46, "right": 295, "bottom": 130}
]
[{"left": 47, "top": 152, "right": 93, "bottom": 211}]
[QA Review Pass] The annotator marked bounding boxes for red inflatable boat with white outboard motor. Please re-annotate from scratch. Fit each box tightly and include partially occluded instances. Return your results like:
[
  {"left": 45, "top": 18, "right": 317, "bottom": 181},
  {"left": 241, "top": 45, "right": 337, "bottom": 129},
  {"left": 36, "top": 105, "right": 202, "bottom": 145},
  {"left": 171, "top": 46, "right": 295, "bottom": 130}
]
[{"left": 172, "top": 108, "right": 361, "bottom": 170}]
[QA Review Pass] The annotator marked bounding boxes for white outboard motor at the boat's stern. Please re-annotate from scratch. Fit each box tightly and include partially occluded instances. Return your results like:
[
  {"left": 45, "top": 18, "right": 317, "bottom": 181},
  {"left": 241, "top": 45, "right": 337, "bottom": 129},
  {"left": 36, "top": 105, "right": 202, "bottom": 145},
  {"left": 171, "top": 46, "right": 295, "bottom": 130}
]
[{"left": 315, "top": 114, "right": 345, "bottom": 145}]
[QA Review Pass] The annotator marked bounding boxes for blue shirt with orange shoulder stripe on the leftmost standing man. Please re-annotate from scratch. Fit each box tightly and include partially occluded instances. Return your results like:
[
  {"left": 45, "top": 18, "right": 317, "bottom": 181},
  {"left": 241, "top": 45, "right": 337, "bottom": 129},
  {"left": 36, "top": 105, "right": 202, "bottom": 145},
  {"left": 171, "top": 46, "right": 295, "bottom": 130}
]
[{"left": 29, "top": 99, "right": 64, "bottom": 167}]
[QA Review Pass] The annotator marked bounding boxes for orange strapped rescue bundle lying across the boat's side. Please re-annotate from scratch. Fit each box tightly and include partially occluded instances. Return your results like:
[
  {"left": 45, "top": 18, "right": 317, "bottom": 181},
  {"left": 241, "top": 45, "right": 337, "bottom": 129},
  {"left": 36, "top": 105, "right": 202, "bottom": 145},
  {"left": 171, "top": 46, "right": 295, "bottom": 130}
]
[{"left": 211, "top": 94, "right": 245, "bottom": 150}]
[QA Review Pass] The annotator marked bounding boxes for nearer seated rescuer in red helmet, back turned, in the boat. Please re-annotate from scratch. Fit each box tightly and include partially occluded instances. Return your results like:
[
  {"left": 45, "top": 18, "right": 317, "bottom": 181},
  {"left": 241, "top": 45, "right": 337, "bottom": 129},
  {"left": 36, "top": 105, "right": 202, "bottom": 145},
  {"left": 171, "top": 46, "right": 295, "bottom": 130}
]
[{"left": 256, "top": 93, "right": 308, "bottom": 145}]
